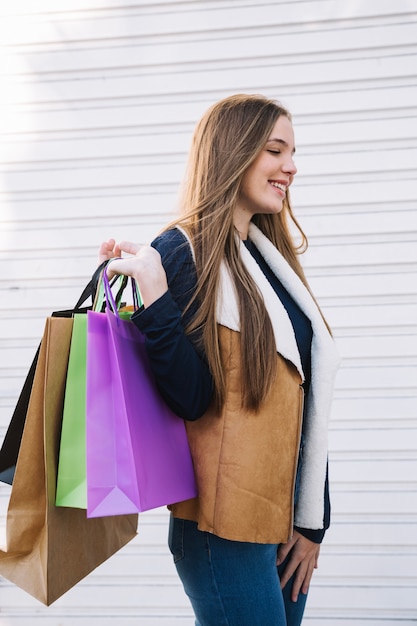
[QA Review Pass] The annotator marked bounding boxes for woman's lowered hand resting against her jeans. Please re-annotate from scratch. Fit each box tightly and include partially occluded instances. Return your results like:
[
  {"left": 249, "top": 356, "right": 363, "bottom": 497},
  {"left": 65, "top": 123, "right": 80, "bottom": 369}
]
[{"left": 277, "top": 530, "right": 320, "bottom": 602}]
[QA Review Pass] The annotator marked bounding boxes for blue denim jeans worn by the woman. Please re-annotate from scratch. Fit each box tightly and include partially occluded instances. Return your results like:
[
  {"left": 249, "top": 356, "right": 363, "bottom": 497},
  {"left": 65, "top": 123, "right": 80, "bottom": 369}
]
[{"left": 169, "top": 516, "right": 307, "bottom": 626}]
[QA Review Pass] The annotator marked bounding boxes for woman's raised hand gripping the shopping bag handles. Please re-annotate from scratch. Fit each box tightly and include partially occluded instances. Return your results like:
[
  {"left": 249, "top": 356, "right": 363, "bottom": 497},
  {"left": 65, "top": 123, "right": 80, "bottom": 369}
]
[{"left": 99, "top": 239, "right": 168, "bottom": 308}]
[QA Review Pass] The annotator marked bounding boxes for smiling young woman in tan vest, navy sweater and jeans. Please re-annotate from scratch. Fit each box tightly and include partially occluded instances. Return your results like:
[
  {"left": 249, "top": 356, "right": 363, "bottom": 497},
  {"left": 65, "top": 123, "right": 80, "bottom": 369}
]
[{"left": 100, "top": 95, "right": 338, "bottom": 626}]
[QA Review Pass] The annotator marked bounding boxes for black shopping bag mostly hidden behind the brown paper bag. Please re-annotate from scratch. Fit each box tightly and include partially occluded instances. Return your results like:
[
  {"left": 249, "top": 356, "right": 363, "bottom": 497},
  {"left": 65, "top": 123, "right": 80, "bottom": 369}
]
[{"left": 0, "top": 264, "right": 102, "bottom": 485}]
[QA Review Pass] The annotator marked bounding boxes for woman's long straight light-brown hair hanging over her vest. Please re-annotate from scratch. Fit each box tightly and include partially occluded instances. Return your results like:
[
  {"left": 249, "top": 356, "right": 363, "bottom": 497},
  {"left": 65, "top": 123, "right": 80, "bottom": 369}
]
[{"left": 166, "top": 94, "right": 308, "bottom": 411}]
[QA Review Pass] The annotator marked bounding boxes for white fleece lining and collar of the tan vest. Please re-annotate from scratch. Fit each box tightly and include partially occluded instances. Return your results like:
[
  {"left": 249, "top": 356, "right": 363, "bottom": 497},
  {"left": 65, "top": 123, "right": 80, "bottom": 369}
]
[{"left": 176, "top": 223, "right": 340, "bottom": 530}]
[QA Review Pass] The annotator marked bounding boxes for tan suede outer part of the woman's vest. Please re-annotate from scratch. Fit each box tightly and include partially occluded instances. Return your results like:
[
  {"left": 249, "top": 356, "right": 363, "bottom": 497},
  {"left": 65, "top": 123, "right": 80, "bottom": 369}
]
[{"left": 169, "top": 326, "right": 303, "bottom": 543}]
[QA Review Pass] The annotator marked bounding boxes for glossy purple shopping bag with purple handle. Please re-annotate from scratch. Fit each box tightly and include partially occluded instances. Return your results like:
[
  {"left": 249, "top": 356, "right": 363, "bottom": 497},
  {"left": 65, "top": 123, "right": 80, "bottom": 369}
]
[{"left": 86, "top": 273, "right": 197, "bottom": 517}]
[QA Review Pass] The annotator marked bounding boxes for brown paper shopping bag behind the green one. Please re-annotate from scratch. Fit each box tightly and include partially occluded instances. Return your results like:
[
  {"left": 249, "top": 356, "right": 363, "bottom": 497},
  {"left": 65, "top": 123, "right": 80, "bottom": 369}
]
[{"left": 0, "top": 317, "right": 137, "bottom": 605}]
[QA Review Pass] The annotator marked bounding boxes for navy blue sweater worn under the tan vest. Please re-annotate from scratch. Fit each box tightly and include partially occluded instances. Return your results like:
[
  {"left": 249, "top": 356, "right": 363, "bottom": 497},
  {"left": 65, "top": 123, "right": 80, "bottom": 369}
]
[{"left": 132, "top": 229, "right": 330, "bottom": 543}]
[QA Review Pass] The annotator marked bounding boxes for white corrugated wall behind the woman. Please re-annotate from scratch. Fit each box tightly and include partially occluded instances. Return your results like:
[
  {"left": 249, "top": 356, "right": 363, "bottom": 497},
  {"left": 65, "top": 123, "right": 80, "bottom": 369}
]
[{"left": 0, "top": 0, "right": 417, "bottom": 626}]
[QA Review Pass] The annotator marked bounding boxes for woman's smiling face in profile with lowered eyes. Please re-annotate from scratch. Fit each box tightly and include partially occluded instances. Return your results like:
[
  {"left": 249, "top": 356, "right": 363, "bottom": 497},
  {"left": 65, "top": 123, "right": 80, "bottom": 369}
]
[{"left": 233, "top": 115, "right": 297, "bottom": 239}]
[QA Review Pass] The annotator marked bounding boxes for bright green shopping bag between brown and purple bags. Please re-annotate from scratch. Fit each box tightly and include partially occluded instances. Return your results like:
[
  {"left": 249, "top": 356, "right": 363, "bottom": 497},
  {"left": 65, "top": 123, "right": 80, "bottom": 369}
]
[{"left": 55, "top": 313, "right": 87, "bottom": 509}]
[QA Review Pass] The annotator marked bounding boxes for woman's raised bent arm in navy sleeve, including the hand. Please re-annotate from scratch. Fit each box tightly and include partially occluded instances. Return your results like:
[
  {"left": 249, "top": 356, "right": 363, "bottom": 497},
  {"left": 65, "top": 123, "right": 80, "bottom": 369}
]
[{"left": 100, "top": 230, "right": 213, "bottom": 420}]
